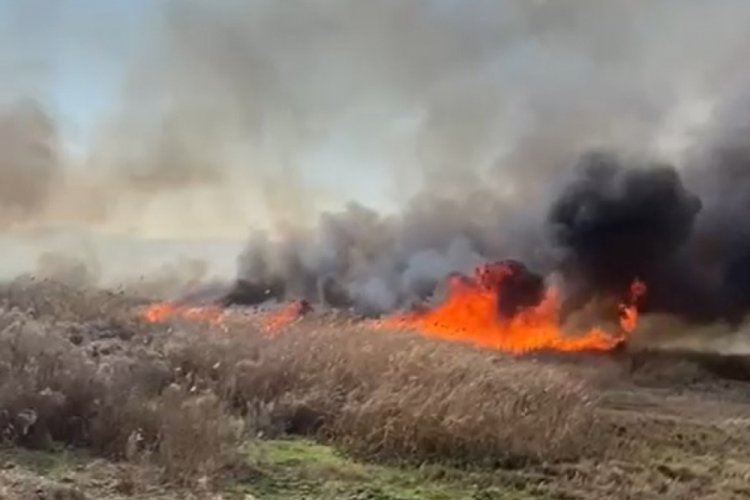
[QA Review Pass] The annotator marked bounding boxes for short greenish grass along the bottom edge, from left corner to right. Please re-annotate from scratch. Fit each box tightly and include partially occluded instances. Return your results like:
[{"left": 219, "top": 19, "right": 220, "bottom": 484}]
[{"left": 8, "top": 439, "right": 750, "bottom": 500}]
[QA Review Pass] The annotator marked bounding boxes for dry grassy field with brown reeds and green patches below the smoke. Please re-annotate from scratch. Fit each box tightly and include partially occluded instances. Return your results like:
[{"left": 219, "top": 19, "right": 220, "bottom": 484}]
[{"left": 0, "top": 280, "right": 750, "bottom": 500}]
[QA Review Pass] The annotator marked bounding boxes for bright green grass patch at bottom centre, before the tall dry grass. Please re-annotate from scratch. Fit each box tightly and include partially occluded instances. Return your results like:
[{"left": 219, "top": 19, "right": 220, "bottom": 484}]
[{"left": 231, "top": 439, "right": 544, "bottom": 500}]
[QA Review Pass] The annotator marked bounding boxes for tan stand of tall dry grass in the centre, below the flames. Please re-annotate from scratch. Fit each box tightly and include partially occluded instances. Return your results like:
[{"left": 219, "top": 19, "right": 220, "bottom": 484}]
[{"left": 165, "top": 316, "right": 596, "bottom": 464}]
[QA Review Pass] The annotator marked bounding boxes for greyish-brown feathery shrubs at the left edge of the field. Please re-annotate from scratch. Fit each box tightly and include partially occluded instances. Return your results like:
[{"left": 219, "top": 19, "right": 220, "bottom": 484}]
[{"left": 0, "top": 304, "right": 238, "bottom": 482}]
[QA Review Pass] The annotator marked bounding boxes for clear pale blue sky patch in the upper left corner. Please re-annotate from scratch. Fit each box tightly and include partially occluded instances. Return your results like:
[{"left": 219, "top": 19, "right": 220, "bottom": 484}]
[{"left": 0, "top": 0, "right": 153, "bottom": 149}]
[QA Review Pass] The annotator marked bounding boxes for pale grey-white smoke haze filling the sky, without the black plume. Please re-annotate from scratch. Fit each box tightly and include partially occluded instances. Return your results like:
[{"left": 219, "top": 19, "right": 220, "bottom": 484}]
[{"left": 0, "top": 0, "right": 750, "bottom": 304}]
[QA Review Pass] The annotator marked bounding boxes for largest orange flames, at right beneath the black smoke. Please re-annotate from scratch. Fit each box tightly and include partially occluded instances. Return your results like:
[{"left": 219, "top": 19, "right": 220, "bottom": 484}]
[{"left": 378, "top": 263, "right": 646, "bottom": 354}]
